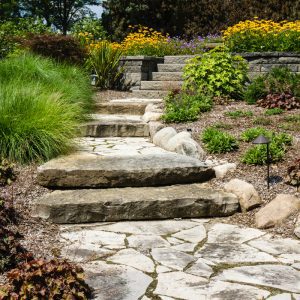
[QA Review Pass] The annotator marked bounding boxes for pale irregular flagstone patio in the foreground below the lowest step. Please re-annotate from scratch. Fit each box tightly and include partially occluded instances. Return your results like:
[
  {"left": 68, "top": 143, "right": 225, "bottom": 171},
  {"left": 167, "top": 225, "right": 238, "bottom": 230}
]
[{"left": 61, "top": 219, "right": 300, "bottom": 300}]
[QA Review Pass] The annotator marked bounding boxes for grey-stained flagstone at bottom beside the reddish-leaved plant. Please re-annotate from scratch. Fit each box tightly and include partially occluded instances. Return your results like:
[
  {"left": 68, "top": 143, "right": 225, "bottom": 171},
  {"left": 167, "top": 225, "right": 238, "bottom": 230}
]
[{"left": 83, "top": 261, "right": 152, "bottom": 300}]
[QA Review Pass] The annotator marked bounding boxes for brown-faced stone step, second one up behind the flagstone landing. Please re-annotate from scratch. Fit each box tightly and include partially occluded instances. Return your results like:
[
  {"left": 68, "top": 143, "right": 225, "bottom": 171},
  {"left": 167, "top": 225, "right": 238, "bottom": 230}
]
[{"left": 94, "top": 101, "right": 147, "bottom": 115}]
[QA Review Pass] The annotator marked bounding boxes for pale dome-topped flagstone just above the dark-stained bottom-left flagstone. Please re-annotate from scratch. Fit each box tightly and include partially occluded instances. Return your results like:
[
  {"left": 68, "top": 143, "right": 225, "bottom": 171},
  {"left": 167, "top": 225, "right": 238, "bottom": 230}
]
[{"left": 108, "top": 249, "right": 154, "bottom": 273}]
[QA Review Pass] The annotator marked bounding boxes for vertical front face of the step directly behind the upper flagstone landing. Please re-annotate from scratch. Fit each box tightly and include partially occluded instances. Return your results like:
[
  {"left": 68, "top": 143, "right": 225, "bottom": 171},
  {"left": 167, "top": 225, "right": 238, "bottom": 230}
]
[{"left": 81, "top": 124, "right": 149, "bottom": 137}]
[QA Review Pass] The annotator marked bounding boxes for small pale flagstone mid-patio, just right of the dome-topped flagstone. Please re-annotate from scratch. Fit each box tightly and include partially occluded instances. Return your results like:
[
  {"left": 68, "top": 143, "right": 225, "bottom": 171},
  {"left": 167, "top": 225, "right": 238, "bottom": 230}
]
[{"left": 151, "top": 248, "right": 195, "bottom": 271}]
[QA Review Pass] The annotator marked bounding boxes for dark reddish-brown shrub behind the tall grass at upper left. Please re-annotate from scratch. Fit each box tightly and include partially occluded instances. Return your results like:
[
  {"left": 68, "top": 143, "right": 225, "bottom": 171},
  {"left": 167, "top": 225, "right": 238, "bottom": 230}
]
[{"left": 23, "top": 34, "right": 86, "bottom": 65}]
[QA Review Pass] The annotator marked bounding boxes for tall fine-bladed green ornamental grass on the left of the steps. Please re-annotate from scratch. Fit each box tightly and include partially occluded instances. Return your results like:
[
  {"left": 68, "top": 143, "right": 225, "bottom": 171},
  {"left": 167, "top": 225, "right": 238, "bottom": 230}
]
[{"left": 0, "top": 54, "right": 92, "bottom": 163}]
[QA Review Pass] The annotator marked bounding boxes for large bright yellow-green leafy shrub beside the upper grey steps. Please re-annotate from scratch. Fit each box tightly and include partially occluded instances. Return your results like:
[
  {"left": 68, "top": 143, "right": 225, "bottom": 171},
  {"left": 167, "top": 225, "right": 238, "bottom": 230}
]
[{"left": 183, "top": 47, "right": 247, "bottom": 99}]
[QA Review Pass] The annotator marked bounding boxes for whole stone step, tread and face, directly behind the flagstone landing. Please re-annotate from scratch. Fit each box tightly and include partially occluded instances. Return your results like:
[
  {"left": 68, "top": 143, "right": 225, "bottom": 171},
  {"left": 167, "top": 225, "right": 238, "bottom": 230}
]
[{"left": 81, "top": 114, "right": 149, "bottom": 137}]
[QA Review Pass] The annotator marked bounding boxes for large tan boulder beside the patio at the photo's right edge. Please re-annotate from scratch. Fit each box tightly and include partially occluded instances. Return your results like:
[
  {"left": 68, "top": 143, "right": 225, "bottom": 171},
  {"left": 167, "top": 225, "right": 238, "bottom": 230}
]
[{"left": 255, "top": 194, "right": 300, "bottom": 228}]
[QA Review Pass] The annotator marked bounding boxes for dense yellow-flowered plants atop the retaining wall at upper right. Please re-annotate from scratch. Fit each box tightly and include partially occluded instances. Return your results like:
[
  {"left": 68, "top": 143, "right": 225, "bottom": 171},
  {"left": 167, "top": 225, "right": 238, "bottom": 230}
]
[{"left": 223, "top": 18, "right": 300, "bottom": 52}]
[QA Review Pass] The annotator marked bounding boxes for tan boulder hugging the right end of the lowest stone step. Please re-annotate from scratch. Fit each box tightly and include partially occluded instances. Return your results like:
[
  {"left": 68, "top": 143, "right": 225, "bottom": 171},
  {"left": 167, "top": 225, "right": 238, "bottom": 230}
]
[{"left": 225, "top": 179, "right": 262, "bottom": 211}]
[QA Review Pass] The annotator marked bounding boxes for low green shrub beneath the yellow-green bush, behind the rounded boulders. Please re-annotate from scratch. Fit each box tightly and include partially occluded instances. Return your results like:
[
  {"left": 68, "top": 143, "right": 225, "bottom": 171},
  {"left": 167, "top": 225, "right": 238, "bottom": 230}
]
[{"left": 162, "top": 91, "right": 212, "bottom": 123}]
